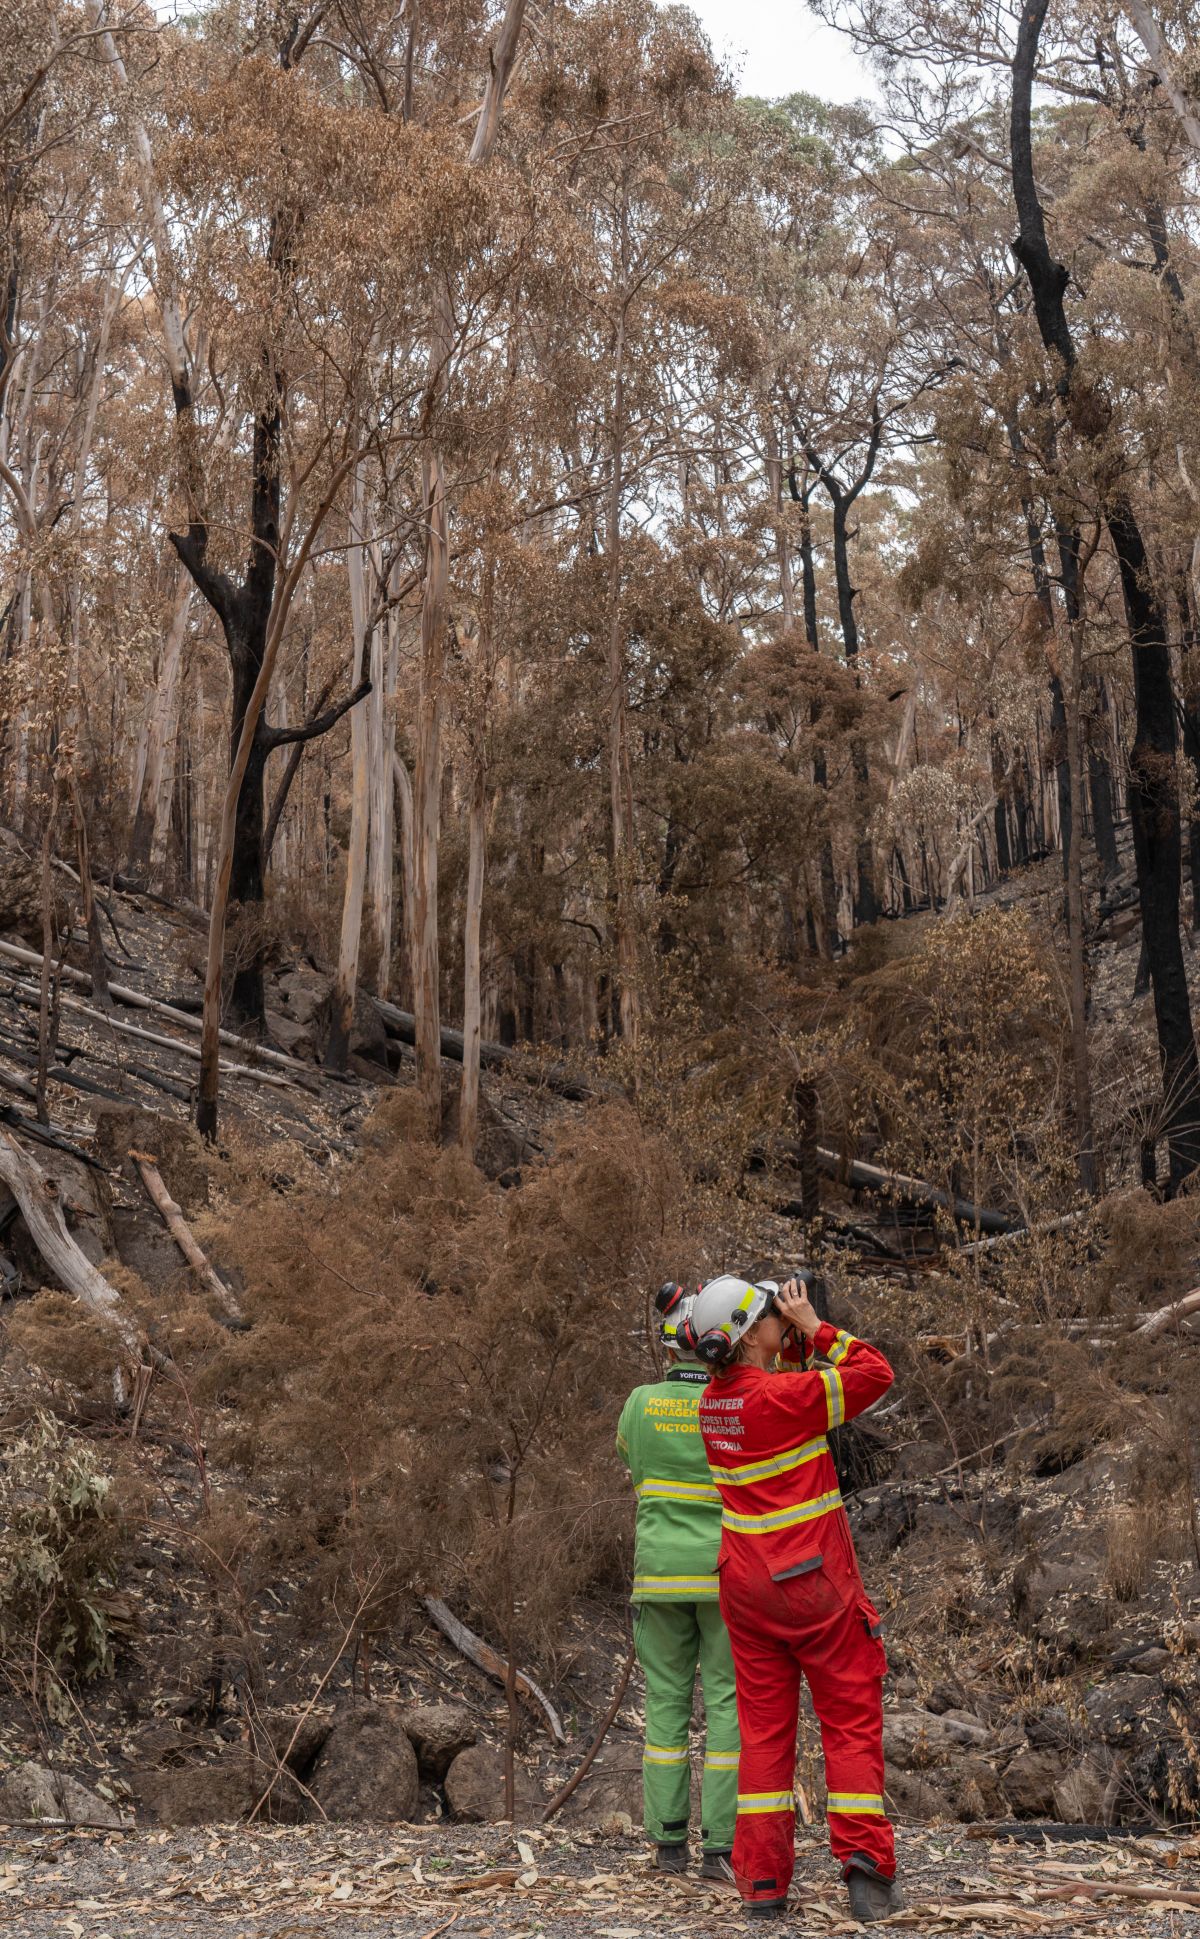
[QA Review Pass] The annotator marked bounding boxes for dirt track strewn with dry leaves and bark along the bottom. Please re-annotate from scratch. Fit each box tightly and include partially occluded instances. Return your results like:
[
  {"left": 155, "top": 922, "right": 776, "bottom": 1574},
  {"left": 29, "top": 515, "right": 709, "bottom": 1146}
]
[{"left": 0, "top": 1825, "right": 1200, "bottom": 1939}]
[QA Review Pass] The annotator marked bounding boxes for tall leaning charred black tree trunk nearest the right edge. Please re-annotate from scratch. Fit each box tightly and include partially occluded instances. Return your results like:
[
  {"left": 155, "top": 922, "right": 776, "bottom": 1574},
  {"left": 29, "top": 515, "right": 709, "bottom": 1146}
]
[{"left": 1010, "top": 0, "right": 1200, "bottom": 1191}]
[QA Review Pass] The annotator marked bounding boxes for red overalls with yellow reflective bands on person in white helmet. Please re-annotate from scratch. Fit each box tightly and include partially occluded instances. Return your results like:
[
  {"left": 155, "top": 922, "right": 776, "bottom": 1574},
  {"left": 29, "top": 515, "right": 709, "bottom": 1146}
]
[{"left": 700, "top": 1324, "right": 896, "bottom": 1900}]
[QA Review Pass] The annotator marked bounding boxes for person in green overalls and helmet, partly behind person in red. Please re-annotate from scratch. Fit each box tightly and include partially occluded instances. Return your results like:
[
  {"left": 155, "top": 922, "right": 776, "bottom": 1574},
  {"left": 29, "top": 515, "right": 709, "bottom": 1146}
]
[{"left": 616, "top": 1286, "right": 739, "bottom": 1883}]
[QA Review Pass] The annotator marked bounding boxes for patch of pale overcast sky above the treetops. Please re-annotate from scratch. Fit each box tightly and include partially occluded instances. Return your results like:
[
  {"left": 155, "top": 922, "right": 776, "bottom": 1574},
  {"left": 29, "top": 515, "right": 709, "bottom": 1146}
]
[{"left": 688, "top": 0, "right": 874, "bottom": 101}]
